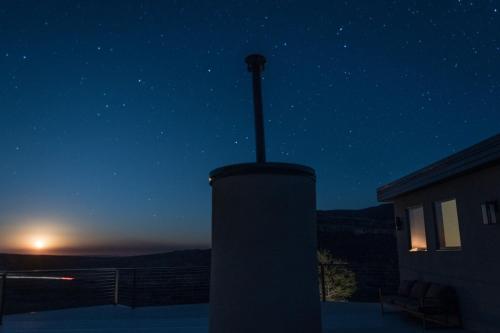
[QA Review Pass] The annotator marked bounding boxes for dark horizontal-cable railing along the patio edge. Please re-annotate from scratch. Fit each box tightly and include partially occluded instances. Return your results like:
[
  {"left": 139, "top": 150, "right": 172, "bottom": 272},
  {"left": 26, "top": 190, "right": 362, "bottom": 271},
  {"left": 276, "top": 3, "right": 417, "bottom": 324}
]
[{"left": 0, "top": 264, "right": 346, "bottom": 324}]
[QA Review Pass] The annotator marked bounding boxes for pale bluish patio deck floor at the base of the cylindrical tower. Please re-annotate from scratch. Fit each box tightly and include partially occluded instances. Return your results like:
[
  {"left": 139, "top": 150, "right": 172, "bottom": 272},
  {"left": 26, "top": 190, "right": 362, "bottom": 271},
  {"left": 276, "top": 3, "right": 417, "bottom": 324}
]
[{"left": 0, "top": 303, "right": 466, "bottom": 333}]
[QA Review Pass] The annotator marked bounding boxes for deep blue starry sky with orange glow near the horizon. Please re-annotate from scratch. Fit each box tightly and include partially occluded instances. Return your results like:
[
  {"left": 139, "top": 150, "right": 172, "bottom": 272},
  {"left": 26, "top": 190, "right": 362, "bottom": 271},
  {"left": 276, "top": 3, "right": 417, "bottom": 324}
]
[{"left": 0, "top": 0, "right": 500, "bottom": 254}]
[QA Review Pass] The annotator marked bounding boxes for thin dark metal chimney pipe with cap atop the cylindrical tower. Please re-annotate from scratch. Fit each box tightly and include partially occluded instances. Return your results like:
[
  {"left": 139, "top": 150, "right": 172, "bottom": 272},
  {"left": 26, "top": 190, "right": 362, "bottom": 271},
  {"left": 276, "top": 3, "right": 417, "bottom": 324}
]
[{"left": 245, "top": 54, "right": 266, "bottom": 163}]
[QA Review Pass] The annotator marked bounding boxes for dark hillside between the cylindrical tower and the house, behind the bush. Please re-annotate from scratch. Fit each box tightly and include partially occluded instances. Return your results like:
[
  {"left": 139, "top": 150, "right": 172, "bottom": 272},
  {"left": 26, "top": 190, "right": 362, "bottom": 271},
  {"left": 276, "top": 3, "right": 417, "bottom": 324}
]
[{"left": 317, "top": 205, "right": 399, "bottom": 301}]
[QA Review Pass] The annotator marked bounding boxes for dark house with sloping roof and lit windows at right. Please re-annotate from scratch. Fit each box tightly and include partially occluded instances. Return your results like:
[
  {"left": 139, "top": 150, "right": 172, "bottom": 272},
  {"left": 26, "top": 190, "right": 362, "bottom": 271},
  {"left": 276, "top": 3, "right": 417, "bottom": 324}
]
[{"left": 377, "top": 135, "right": 500, "bottom": 333}]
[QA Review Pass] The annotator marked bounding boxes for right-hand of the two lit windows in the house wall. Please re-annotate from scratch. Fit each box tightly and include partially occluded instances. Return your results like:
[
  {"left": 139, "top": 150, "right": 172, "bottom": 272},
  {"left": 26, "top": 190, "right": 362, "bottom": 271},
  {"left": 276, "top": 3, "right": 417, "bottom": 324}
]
[{"left": 434, "top": 199, "right": 462, "bottom": 249}]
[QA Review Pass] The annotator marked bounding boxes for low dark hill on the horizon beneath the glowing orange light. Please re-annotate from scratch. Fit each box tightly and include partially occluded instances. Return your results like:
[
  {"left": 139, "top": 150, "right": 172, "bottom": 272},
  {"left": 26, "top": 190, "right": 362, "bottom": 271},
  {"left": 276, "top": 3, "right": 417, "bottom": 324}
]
[{"left": 0, "top": 250, "right": 210, "bottom": 271}]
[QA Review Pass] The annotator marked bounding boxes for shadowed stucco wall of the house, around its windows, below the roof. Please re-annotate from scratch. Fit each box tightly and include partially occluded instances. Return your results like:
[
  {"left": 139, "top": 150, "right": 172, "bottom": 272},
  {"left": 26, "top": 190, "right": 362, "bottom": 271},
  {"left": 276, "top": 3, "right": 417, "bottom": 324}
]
[{"left": 393, "top": 163, "right": 500, "bottom": 333}]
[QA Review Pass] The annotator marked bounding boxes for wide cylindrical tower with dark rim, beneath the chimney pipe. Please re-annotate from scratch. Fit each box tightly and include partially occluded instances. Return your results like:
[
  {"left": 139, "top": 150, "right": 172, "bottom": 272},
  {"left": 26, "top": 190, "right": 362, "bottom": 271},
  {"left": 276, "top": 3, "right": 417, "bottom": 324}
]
[{"left": 210, "top": 163, "right": 321, "bottom": 333}]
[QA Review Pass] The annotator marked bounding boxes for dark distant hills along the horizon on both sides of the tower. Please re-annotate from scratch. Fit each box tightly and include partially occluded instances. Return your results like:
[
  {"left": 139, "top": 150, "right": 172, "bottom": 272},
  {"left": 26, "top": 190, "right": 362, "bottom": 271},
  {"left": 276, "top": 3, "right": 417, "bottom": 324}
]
[{"left": 0, "top": 204, "right": 396, "bottom": 270}]
